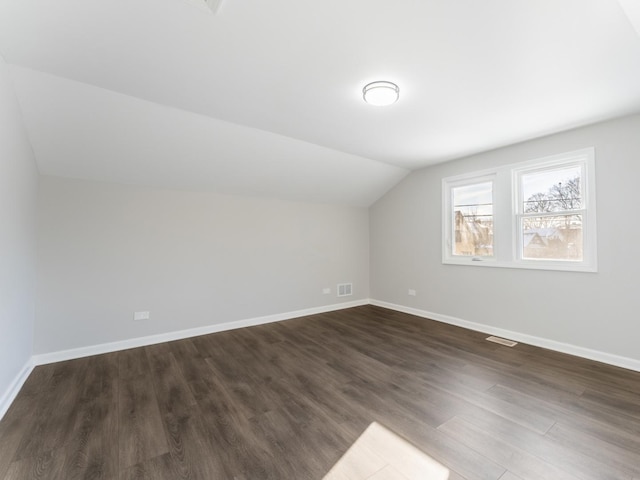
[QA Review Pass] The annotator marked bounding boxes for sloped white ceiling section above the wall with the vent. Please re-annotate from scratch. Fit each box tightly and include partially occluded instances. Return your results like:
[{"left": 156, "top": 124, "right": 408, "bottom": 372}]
[{"left": 12, "top": 67, "right": 406, "bottom": 206}]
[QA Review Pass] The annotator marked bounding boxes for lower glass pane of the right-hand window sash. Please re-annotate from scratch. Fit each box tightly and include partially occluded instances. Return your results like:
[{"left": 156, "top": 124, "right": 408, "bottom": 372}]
[{"left": 522, "top": 215, "right": 582, "bottom": 261}]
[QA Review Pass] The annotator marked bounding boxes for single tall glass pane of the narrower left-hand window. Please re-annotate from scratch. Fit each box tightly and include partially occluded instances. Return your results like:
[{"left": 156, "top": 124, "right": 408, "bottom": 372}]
[{"left": 452, "top": 182, "right": 493, "bottom": 257}]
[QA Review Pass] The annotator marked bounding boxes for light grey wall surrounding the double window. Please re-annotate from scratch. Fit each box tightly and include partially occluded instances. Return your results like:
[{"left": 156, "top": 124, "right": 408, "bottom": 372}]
[{"left": 370, "top": 116, "right": 640, "bottom": 361}]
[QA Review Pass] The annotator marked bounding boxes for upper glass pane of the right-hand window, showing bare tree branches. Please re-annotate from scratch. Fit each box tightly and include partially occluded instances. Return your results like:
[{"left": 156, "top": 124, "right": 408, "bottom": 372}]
[{"left": 522, "top": 165, "right": 582, "bottom": 213}]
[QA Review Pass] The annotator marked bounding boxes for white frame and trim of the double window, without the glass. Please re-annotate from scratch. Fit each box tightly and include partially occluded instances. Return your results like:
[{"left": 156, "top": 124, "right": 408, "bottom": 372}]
[{"left": 442, "top": 147, "right": 598, "bottom": 272}]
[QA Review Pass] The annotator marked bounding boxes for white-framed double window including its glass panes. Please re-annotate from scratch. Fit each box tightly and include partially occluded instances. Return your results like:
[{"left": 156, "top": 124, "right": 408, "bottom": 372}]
[{"left": 442, "top": 148, "right": 597, "bottom": 272}]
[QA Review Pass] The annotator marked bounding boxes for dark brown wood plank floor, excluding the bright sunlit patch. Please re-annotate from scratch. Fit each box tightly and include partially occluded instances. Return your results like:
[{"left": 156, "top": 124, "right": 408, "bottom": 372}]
[{"left": 0, "top": 306, "right": 640, "bottom": 480}]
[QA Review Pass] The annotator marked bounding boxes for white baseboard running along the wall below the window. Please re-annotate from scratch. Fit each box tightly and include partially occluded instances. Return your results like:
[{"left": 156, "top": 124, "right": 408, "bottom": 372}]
[{"left": 370, "top": 299, "right": 640, "bottom": 372}]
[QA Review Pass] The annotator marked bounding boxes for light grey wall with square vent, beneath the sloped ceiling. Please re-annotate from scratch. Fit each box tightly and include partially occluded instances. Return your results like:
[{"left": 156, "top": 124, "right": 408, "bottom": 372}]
[{"left": 35, "top": 176, "right": 369, "bottom": 354}]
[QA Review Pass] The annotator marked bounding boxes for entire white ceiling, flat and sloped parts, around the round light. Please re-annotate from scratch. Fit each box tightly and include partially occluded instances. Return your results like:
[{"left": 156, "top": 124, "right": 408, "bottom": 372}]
[{"left": 0, "top": 0, "right": 640, "bottom": 205}]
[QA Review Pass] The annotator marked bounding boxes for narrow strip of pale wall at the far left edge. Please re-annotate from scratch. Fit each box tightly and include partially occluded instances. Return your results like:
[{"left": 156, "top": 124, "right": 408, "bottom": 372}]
[{"left": 0, "top": 57, "right": 38, "bottom": 408}]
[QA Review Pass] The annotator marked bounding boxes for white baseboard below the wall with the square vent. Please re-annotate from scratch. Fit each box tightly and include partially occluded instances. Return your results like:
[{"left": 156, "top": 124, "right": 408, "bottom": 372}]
[{"left": 32, "top": 299, "right": 369, "bottom": 365}]
